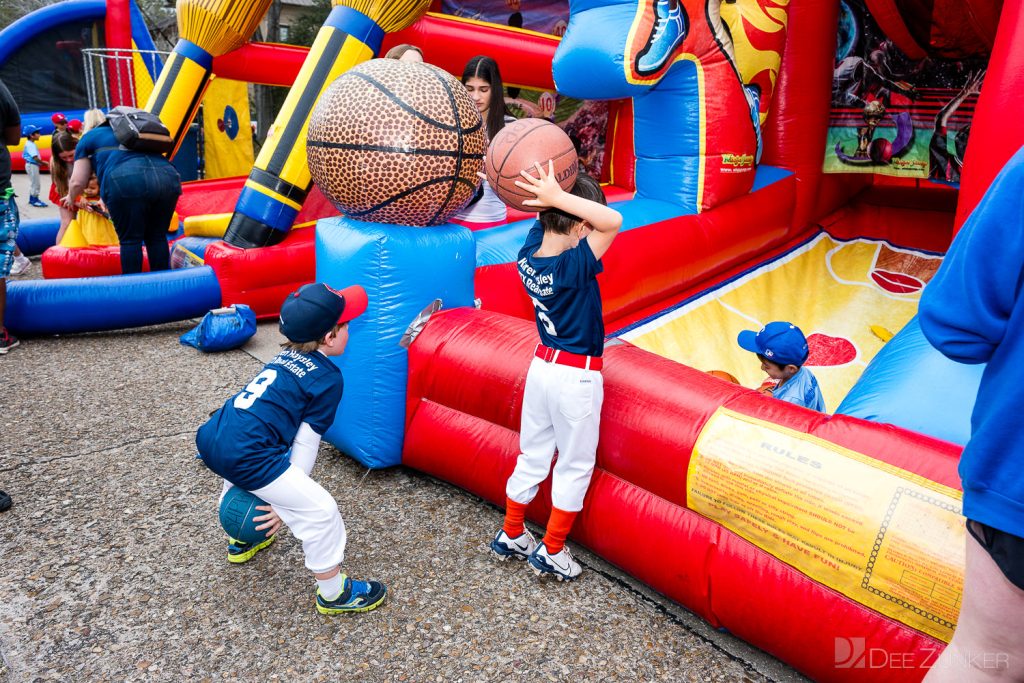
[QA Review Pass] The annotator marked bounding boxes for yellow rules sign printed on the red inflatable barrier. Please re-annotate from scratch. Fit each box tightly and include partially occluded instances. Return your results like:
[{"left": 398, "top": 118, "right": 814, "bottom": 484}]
[{"left": 686, "top": 408, "right": 965, "bottom": 642}]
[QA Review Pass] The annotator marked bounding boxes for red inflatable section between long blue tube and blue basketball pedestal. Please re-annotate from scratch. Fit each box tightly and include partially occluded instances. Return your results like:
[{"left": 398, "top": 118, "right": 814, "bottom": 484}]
[{"left": 205, "top": 226, "right": 316, "bottom": 319}]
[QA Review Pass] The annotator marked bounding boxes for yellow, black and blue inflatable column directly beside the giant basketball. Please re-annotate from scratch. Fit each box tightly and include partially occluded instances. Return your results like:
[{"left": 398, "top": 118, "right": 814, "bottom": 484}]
[{"left": 224, "top": 0, "right": 430, "bottom": 249}]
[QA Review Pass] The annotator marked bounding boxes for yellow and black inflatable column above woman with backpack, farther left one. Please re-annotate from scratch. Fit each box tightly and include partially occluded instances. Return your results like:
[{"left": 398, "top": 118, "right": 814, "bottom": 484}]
[{"left": 144, "top": 0, "right": 271, "bottom": 157}]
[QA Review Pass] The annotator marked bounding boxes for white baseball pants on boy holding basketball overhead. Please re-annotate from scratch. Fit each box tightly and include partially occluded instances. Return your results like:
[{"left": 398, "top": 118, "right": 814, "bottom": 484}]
[{"left": 505, "top": 358, "right": 604, "bottom": 512}]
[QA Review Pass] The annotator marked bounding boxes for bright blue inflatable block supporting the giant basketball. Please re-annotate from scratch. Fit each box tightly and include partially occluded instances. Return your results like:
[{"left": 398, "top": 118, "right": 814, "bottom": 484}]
[{"left": 316, "top": 217, "right": 476, "bottom": 468}]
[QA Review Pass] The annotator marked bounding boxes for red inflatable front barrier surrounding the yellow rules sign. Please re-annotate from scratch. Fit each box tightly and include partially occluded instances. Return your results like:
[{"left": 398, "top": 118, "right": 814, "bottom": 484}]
[{"left": 402, "top": 309, "right": 958, "bottom": 681}]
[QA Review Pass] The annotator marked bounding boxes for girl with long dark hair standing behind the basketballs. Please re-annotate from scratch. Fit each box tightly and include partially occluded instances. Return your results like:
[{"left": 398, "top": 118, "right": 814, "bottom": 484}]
[{"left": 452, "top": 54, "right": 515, "bottom": 230}]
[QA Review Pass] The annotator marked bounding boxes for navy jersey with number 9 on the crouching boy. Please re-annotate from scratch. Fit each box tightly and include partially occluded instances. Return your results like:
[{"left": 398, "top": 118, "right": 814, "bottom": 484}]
[{"left": 196, "top": 349, "right": 344, "bottom": 490}]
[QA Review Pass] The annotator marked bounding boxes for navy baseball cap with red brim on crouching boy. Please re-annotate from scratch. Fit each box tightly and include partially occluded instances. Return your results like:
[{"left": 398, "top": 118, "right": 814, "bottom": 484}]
[{"left": 279, "top": 283, "right": 368, "bottom": 344}]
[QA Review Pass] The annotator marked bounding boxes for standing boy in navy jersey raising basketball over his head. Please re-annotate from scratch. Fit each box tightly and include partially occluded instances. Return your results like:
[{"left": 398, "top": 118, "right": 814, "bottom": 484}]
[{"left": 490, "top": 162, "right": 623, "bottom": 581}]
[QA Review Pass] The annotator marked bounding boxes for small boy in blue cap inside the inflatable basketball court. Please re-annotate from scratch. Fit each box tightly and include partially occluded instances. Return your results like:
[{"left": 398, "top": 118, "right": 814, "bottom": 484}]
[{"left": 736, "top": 321, "right": 825, "bottom": 413}]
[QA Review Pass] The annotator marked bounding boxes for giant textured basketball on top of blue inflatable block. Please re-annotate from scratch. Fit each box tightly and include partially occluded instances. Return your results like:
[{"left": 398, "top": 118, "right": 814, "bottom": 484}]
[{"left": 306, "top": 59, "right": 484, "bottom": 225}]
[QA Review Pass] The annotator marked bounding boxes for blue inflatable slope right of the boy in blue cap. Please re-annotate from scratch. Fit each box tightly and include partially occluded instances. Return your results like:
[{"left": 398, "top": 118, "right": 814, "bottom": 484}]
[{"left": 836, "top": 315, "right": 985, "bottom": 445}]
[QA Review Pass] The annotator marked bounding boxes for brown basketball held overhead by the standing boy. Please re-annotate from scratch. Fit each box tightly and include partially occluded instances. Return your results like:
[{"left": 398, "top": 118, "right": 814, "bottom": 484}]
[{"left": 483, "top": 119, "right": 580, "bottom": 211}]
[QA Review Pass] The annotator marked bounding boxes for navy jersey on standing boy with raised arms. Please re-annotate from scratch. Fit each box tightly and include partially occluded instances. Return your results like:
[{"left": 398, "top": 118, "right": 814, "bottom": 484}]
[{"left": 517, "top": 221, "right": 604, "bottom": 356}]
